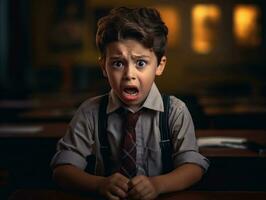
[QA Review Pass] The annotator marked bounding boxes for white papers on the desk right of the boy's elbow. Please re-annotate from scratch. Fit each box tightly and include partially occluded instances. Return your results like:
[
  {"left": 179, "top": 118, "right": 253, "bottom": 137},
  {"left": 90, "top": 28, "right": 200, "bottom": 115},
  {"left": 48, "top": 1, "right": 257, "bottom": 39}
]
[{"left": 197, "top": 136, "right": 247, "bottom": 149}]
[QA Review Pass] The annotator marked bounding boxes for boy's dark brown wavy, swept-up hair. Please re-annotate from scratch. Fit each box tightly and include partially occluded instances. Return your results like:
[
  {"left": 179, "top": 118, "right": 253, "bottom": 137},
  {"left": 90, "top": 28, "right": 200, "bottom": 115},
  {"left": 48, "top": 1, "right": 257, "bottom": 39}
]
[{"left": 96, "top": 7, "right": 168, "bottom": 62}]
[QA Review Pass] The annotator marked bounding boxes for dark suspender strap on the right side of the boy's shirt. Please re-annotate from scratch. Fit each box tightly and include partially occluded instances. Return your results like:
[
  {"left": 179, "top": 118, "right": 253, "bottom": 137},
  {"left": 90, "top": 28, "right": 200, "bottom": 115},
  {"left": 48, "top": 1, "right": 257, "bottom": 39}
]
[{"left": 159, "top": 95, "right": 173, "bottom": 174}]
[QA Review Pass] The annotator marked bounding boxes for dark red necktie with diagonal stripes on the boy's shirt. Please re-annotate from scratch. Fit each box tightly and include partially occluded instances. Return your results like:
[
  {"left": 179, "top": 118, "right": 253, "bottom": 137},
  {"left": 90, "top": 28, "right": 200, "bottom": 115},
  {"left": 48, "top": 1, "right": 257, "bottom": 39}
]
[{"left": 119, "top": 111, "right": 140, "bottom": 178}]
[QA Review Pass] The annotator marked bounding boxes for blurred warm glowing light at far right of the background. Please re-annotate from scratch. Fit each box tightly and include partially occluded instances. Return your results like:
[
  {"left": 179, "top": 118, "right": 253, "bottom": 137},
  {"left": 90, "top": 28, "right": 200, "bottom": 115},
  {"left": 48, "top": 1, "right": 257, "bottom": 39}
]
[{"left": 234, "top": 5, "right": 261, "bottom": 46}]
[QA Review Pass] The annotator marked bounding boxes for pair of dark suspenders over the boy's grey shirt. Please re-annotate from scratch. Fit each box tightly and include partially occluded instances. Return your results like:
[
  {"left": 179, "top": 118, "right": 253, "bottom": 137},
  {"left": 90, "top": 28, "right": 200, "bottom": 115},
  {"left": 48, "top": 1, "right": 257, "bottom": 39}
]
[{"left": 98, "top": 95, "right": 173, "bottom": 176}]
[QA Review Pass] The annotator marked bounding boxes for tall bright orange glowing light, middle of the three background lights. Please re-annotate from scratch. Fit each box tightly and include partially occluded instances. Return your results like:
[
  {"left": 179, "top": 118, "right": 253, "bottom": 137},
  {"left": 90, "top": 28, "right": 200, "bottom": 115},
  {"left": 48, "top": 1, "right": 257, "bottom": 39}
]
[{"left": 192, "top": 4, "right": 221, "bottom": 54}]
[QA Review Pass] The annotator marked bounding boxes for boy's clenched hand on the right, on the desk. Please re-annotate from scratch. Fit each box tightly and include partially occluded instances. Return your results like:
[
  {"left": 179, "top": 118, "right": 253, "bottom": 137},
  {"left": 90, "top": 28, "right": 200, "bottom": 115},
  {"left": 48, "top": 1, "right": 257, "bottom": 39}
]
[{"left": 128, "top": 176, "right": 159, "bottom": 200}]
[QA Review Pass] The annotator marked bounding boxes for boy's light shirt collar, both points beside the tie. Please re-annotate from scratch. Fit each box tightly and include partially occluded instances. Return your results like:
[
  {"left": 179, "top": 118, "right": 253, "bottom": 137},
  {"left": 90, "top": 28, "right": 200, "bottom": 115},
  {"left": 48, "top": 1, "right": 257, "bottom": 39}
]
[{"left": 106, "top": 83, "right": 164, "bottom": 114}]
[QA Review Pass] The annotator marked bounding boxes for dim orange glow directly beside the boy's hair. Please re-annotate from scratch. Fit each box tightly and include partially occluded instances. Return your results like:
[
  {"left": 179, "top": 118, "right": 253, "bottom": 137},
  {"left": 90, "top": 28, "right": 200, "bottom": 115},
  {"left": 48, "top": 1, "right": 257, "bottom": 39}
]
[{"left": 157, "top": 6, "right": 180, "bottom": 47}]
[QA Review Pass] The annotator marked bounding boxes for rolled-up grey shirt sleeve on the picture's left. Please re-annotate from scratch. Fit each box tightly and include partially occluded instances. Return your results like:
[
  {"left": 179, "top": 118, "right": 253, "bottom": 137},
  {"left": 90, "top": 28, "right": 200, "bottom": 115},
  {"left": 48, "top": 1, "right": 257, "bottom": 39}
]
[{"left": 50, "top": 101, "right": 95, "bottom": 169}]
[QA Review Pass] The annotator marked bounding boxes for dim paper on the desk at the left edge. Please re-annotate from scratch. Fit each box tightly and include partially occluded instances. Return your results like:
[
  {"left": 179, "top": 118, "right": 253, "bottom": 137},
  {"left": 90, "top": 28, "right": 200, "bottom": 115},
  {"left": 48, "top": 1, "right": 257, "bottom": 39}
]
[{"left": 0, "top": 126, "right": 43, "bottom": 134}]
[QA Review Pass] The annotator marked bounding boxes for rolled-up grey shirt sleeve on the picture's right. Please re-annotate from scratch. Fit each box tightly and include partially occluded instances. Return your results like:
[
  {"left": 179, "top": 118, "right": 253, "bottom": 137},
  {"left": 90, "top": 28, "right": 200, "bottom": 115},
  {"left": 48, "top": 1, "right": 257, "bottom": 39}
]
[{"left": 169, "top": 96, "right": 209, "bottom": 171}]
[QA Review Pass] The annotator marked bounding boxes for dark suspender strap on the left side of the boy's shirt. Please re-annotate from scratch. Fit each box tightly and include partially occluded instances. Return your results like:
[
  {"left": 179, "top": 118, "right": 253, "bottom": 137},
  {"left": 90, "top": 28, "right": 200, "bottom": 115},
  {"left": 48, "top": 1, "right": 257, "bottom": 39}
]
[{"left": 98, "top": 94, "right": 111, "bottom": 176}]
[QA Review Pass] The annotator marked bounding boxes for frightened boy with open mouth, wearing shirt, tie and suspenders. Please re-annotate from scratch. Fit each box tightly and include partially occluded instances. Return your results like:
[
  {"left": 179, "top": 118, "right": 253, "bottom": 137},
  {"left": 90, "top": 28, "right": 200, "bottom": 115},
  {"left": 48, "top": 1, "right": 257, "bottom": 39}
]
[{"left": 51, "top": 7, "right": 208, "bottom": 200}]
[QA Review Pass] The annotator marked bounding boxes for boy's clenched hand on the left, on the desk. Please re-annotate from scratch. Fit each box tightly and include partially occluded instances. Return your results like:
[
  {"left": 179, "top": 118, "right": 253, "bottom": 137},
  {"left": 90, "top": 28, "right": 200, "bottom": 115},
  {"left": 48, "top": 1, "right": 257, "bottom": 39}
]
[{"left": 98, "top": 173, "right": 129, "bottom": 200}]
